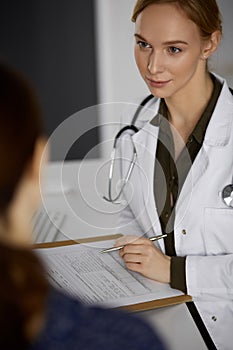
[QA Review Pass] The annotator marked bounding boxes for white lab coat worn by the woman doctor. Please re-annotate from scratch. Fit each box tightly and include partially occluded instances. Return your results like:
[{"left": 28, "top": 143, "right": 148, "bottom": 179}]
[{"left": 119, "top": 77, "right": 233, "bottom": 350}]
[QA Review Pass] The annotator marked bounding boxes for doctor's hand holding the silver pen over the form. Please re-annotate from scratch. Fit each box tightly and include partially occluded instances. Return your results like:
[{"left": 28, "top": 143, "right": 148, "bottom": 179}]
[{"left": 114, "top": 236, "right": 171, "bottom": 283}]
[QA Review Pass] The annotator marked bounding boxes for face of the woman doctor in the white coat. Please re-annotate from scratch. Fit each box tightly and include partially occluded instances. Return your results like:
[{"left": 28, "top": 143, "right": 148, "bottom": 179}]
[{"left": 135, "top": 3, "right": 206, "bottom": 98}]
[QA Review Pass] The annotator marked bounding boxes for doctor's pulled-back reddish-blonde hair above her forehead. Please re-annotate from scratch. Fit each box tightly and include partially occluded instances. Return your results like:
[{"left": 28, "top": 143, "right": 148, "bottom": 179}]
[{"left": 131, "top": 0, "right": 222, "bottom": 39}]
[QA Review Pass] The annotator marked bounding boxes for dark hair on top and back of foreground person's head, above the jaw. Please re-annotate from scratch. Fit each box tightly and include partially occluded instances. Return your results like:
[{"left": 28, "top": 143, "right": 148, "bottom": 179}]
[{"left": 0, "top": 63, "right": 44, "bottom": 215}]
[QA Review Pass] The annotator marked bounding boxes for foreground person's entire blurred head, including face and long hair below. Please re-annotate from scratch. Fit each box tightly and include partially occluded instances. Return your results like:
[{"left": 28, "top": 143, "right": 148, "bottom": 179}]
[{"left": 0, "top": 63, "right": 48, "bottom": 350}]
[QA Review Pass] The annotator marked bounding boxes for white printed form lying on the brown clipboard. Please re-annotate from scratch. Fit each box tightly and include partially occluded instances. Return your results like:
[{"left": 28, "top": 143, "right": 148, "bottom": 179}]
[{"left": 36, "top": 240, "right": 187, "bottom": 307}]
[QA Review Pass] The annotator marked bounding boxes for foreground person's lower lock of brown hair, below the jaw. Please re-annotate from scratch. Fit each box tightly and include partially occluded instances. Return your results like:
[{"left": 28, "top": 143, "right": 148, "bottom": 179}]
[{"left": 0, "top": 243, "right": 48, "bottom": 350}]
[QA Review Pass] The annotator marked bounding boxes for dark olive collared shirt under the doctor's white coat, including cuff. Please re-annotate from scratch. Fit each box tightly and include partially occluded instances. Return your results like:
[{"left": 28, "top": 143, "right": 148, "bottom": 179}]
[{"left": 151, "top": 75, "right": 222, "bottom": 293}]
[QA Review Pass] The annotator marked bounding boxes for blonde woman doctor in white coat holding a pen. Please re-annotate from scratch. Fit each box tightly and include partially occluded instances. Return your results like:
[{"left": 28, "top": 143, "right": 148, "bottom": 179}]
[{"left": 115, "top": 0, "right": 233, "bottom": 349}]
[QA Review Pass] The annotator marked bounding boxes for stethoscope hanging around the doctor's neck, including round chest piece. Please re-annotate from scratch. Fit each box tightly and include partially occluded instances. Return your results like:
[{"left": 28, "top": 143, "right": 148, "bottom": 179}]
[{"left": 103, "top": 95, "right": 233, "bottom": 208}]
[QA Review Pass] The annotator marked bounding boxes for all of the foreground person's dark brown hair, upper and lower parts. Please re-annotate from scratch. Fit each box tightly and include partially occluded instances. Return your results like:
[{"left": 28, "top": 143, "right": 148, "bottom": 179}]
[{"left": 0, "top": 63, "right": 48, "bottom": 350}]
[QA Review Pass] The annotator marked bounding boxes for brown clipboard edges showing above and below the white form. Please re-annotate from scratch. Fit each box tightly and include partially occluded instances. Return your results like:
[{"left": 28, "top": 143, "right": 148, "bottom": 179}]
[{"left": 33, "top": 234, "right": 192, "bottom": 312}]
